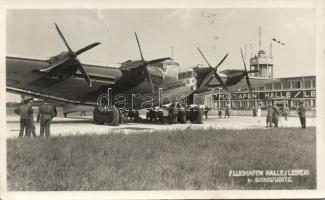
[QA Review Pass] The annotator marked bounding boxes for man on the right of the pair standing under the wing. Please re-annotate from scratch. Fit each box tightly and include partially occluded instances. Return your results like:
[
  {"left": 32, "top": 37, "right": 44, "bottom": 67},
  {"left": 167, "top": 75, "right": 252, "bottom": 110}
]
[{"left": 37, "top": 100, "right": 55, "bottom": 137}]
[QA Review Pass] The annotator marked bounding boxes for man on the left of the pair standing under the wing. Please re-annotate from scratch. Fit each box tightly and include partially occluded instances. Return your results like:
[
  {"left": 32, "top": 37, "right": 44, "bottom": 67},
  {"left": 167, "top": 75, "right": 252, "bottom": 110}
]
[{"left": 15, "top": 99, "right": 33, "bottom": 137}]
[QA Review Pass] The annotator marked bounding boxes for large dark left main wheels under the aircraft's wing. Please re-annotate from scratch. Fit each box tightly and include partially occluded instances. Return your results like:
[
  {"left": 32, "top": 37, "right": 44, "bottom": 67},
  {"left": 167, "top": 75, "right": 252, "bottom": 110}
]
[{"left": 93, "top": 107, "right": 120, "bottom": 126}]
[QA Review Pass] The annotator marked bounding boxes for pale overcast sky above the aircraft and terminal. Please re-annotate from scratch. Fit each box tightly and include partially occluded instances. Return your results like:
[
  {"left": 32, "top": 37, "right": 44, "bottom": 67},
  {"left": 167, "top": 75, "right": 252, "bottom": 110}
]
[{"left": 6, "top": 8, "right": 315, "bottom": 101}]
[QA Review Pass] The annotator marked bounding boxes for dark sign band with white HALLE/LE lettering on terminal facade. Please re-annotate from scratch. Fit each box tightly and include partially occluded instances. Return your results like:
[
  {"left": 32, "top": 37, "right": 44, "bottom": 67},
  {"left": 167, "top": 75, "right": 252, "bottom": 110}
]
[{"left": 215, "top": 90, "right": 316, "bottom": 100}]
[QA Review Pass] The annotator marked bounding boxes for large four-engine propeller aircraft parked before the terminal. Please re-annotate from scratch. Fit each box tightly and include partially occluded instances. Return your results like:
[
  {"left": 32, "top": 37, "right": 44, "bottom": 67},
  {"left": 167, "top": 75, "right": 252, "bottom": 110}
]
[{"left": 6, "top": 24, "right": 258, "bottom": 124}]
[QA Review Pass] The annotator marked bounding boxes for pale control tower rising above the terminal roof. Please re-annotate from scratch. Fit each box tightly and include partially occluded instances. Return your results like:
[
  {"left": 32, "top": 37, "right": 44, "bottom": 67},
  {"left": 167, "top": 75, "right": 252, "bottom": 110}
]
[{"left": 250, "top": 50, "right": 273, "bottom": 79}]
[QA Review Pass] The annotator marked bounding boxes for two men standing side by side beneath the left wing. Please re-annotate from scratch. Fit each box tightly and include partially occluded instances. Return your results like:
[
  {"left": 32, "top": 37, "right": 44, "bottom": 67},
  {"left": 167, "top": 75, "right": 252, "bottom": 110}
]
[{"left": 15, "top": 99, "right": 56, "bottom": 137}]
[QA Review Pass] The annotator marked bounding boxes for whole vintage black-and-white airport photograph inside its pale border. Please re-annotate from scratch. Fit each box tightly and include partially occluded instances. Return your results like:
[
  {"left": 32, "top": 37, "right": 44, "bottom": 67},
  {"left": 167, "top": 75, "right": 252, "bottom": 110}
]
[{"left": 3, "top": 0, "right": 319, "bottom": 198}]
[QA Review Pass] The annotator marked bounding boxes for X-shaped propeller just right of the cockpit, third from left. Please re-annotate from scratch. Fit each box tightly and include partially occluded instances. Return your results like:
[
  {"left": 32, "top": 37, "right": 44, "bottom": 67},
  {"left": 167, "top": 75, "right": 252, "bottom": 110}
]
[{"left": 197, "top": 47, "right": 229, "bottom": 92}]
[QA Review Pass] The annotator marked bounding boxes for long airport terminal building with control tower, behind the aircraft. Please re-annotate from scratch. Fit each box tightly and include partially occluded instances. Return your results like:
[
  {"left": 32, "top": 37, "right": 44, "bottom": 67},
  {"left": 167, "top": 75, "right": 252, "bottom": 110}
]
[{"left": 194, "top": 51, "right": 316, "bottom": 110}]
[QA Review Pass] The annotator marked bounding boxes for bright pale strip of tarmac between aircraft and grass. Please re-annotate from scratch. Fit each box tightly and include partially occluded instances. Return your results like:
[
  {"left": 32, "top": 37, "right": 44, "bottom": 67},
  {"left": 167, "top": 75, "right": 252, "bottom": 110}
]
[{"left": 7, "top": 115, "right": 316, "bottom": 138}]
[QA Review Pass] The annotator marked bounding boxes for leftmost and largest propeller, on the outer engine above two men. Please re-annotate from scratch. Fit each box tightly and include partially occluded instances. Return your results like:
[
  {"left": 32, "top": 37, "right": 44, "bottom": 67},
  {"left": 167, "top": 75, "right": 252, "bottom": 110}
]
[{"left": 40, "top": 23, "right": 100, "bottom": 87}]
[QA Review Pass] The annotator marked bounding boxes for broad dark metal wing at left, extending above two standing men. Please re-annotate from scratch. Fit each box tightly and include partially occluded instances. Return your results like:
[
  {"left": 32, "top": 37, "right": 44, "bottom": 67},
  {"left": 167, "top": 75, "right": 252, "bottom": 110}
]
[{"left": 6, "top": 57, "right": 123, "bottom": 105}]
